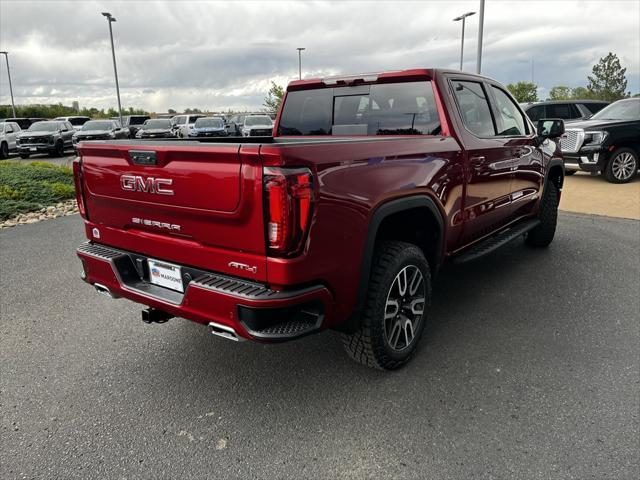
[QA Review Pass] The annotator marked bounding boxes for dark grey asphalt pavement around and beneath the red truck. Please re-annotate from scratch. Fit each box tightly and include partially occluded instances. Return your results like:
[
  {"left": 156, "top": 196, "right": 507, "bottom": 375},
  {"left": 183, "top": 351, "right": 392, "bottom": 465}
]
[{"left": 0, "top": 214, "right": 640, "bottom": 480}]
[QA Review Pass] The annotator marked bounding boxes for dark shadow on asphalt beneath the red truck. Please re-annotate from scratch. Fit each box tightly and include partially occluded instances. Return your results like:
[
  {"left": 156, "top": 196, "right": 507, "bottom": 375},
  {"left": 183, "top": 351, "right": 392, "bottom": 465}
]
[{"left": 121, "top": 232, "right": 580, "bottom": 428}]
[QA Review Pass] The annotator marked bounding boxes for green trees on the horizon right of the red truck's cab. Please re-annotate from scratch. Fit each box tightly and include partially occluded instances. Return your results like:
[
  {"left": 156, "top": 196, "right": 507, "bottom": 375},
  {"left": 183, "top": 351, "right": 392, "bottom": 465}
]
[{"left": 507, "top": 52, "right": 640, "bottom": 103}]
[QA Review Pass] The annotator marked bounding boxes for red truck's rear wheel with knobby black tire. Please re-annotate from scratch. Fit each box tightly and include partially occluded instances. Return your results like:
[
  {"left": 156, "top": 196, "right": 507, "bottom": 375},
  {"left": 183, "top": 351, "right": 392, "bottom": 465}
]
[{"left": 342, "top": 241, "right": 431, "bottom": 370}]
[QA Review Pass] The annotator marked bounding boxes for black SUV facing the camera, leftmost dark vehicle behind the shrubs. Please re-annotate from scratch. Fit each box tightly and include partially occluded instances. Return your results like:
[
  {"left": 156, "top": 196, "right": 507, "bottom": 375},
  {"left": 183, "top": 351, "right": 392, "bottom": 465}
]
[{"left": 16, "top": 120, "right": 75, "bottom": 158}]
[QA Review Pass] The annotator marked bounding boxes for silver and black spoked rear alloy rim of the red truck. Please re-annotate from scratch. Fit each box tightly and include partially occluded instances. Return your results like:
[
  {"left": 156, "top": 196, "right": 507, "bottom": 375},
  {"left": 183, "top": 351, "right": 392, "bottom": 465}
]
[{"left": 384, "top": 265, "right": 426, "bottom": 351}]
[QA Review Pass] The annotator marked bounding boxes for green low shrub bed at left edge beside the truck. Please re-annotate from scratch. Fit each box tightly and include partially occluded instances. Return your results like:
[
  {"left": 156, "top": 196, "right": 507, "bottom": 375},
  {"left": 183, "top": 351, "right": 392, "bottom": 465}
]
[{"left": 0, "top": 162, "right": 75, "bottom": 220}]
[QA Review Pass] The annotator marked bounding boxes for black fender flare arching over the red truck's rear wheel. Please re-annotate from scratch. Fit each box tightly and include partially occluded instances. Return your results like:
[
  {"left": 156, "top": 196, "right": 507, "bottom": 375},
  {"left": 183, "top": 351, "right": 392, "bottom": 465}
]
[{"left": 339, "top": 195, "right": 444, "bottom": 331}]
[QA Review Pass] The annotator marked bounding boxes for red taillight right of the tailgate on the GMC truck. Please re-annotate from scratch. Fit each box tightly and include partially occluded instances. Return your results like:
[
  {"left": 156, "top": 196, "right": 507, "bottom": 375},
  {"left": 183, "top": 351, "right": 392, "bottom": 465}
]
[{"left": 264, "top": 167, "right": 313, "bottom": 256}]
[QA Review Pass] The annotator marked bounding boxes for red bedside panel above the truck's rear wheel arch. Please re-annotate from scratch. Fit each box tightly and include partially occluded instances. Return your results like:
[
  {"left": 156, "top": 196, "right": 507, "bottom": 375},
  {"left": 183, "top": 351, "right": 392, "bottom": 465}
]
[{"left": 260, "top": 136, "right": 464, "bottom": 328}]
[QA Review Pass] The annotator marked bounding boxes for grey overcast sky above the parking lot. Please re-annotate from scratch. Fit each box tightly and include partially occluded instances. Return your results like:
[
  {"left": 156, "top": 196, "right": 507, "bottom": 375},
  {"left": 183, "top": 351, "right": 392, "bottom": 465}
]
[{"left": 0, "top": 0, "right": 640, "bottom": 112}]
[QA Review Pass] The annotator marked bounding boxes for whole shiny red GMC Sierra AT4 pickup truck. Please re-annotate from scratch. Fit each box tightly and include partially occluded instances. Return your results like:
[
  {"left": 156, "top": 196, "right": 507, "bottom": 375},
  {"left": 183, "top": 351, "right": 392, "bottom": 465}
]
[{"left": 74, "top": 69, "right": 564, "bottom": 369}]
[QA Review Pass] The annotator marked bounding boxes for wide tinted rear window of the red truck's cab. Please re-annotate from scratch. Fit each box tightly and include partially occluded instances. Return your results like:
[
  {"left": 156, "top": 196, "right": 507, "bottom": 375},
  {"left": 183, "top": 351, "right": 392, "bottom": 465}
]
[{"left": 278, "top": 80, "right": 441, "bottom": 135}]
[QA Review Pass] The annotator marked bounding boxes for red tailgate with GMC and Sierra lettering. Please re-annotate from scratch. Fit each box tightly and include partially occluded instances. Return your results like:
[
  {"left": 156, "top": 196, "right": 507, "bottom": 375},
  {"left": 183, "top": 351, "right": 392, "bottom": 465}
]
[{"left": 79, "top": 141, "right": 266, "bottom": 280}]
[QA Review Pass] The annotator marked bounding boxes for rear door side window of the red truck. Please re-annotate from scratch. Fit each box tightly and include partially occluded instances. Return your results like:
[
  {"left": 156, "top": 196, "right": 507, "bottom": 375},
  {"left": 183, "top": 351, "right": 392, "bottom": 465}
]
[{"left": 451, "top": 80, "right": 496, "bottom": 137}]
